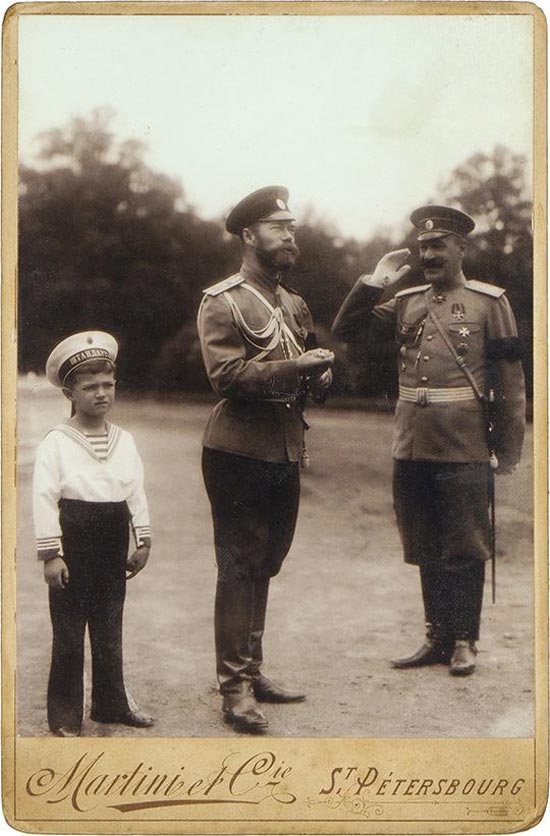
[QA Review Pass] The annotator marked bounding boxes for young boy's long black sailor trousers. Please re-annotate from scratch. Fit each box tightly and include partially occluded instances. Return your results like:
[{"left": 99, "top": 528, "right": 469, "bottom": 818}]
[{"left": 48, "top": 499, "right": 129, "bottom": 731}]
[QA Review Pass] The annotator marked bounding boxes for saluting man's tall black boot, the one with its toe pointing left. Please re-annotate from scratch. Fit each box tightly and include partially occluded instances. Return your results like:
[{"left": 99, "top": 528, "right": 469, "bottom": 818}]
[{"left": 391, "top": 563, "right": 453, "bottom": 669}]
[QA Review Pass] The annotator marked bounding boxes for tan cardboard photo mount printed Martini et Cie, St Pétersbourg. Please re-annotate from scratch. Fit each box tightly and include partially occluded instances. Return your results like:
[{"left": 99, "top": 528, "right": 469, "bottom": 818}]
[{"left": 2, "top": 2, "right": 548, "bottom": 834}]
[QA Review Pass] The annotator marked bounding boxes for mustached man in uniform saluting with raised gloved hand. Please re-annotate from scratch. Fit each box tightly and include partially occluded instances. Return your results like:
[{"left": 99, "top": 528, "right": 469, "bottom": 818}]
[{"left": 333, "top": 206, "right": 525, "bottom": 675}]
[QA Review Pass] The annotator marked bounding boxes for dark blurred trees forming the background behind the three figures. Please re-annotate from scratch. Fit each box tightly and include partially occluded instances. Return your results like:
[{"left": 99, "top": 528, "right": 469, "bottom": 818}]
[{"left": 19, "top": 109, "right": 533, "bottom": 395}]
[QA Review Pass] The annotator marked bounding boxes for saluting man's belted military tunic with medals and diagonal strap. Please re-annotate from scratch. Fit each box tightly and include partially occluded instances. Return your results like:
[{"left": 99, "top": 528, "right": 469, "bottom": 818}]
[{"left": 334, "top": 279, "right": 525, "bottom": 465}]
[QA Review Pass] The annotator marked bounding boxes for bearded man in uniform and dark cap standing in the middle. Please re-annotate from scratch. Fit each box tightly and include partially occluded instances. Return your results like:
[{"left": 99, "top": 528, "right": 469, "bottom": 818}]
[{"left": 198, "top": 186, "right": 334, "bottom": 732}]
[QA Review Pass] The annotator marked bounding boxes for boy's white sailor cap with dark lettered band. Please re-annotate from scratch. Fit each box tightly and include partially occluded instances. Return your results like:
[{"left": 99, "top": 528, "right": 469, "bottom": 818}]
[{"left": 46, "top": 331, "right": 118, "bottom": 386}]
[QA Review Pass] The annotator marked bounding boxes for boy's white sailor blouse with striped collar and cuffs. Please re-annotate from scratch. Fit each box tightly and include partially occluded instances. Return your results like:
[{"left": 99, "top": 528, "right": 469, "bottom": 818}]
[{"left": 33, "top": 423, "right": 151, "bottom": 559}]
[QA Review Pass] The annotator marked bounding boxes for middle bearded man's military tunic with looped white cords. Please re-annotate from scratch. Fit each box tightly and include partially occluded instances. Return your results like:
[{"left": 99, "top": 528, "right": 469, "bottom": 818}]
[{"left": 198, "top": 266, "right": 320, "bottom": 462}]
